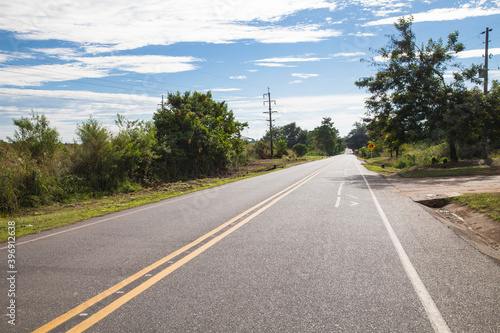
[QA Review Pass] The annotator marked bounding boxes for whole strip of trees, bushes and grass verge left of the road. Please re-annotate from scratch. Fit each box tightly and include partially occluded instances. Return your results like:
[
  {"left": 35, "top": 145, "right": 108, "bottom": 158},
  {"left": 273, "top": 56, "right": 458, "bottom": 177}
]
[{"left": 0, "top": 92, "right": 342, "bottom": 241}]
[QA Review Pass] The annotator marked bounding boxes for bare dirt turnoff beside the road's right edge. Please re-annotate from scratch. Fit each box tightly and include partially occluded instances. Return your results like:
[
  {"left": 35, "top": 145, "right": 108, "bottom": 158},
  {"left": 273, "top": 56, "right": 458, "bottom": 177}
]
[{"left": 386, "top": 175, "right": 500, "bottom": 264}]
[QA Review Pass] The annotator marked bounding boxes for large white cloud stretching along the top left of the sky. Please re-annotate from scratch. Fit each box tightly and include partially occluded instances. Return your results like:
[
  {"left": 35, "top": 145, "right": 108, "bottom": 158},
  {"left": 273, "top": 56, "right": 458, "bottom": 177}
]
[{"left": 0, "top": 0, "right": 340, "bottom": 53}]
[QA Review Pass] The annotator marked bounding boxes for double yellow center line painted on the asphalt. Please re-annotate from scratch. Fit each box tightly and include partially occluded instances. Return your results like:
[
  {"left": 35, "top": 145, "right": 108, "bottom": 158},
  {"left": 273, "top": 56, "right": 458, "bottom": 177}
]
[{"left": 33, "top": 162, "right": 335, "bottom": 333}]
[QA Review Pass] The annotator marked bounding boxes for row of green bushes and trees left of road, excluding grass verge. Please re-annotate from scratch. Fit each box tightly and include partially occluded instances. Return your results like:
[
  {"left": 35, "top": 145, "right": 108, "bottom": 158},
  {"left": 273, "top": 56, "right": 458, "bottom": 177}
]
[{"left": 0, "top": 92, "right": 248, "bottom": 212}]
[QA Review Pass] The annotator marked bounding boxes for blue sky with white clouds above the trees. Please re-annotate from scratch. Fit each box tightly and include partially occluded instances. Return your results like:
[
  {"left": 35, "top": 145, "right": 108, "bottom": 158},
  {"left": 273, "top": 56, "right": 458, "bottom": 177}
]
[{"left": 0, "top": 0, "right": 500, "bottom": 142}]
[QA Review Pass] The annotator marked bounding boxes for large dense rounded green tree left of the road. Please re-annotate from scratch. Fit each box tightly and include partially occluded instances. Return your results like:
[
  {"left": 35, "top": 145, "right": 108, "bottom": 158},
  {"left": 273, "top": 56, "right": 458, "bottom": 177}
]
[{"left": 153, "top": 92, "right": 248, "bottom": 179}]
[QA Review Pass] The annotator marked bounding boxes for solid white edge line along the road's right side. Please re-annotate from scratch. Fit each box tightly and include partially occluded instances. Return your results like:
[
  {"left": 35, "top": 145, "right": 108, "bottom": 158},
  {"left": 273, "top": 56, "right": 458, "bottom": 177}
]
[{"left": 358, "top": 160, "right": 451, "bottom": 333}]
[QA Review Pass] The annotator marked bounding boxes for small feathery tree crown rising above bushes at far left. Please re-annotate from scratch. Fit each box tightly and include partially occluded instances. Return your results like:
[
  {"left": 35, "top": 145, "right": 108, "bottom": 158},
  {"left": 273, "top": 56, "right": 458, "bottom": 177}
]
[{"left": 7, "top": 111, "right": 61, "bottom": 162}]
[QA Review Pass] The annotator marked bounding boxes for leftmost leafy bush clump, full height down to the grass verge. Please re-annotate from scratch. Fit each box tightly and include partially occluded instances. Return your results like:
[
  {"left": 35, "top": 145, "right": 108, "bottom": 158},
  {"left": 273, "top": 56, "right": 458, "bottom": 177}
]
[{"left": 0, "top": 112, "right": 67, "bottom": 213}]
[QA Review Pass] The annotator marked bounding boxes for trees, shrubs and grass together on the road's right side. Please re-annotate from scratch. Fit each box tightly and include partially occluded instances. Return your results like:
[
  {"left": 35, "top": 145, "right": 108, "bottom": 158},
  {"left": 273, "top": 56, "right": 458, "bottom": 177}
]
[{"left": 345, "top": 17, "right": 500, "bottom": 221}]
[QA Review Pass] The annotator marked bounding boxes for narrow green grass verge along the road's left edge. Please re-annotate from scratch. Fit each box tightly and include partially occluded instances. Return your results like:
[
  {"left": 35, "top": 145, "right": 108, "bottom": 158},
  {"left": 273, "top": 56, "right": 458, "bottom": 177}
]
[{"left": 0, "top": 157, "right": 322, "bottom": 242}]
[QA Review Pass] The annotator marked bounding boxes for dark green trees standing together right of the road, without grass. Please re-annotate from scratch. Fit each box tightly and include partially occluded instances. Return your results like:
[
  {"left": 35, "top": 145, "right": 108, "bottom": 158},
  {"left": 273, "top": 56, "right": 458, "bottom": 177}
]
[{"left": 354, "top": 17, "right": 500, "bottom": 161}]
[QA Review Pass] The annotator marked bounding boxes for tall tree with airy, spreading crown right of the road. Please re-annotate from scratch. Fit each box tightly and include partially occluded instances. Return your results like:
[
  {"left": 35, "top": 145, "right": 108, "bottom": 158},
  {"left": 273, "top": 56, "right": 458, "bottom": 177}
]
[{"left": 356, "top": 18, "right": 478, "bottom": 161}]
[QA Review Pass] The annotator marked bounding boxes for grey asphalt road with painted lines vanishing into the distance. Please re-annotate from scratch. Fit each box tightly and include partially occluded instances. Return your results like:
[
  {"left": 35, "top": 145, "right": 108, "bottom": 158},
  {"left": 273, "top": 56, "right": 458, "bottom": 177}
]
[{"left": 0, "top": 154, "right": 500, "bottom": 333}]
